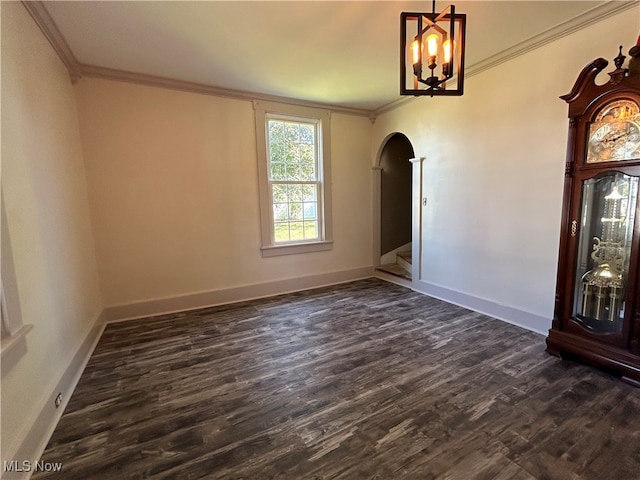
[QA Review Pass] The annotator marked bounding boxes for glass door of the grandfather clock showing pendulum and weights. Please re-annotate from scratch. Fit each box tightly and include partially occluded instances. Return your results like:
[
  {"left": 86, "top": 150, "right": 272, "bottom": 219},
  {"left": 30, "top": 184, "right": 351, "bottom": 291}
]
[{"left": 573, "top": 172, "right": 638, "bottom": 333}]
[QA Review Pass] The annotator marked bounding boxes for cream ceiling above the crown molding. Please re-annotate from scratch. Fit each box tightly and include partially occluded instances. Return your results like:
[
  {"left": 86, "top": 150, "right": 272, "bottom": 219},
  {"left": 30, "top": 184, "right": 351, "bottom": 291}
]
[{"left": 38, "top": 0, "right": 615, "bottom": 111}]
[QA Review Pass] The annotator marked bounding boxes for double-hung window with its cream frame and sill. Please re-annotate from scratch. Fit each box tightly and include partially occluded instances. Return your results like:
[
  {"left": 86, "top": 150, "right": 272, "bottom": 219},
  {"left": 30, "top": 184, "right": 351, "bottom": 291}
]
[{"left": 254, "top": 102, "right": 332, "bottom": 257}]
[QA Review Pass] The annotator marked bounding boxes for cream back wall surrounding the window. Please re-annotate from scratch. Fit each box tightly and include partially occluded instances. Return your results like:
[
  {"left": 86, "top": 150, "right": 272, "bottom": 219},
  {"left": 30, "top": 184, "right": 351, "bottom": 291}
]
[{"left": 76, "top": 78, "right": 372, "bottom": 317}]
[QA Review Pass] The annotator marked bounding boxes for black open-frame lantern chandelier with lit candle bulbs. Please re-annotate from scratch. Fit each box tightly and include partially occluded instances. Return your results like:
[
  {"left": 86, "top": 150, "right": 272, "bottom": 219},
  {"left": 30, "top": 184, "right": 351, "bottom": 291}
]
[{"left": 400, "top": 0, "right": 467, "bottom": 97}]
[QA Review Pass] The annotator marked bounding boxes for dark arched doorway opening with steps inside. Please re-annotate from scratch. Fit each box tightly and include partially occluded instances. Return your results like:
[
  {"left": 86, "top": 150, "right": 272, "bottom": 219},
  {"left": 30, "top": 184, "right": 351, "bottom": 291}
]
[{"left": 376, "top": 133, "right": 415, "bottom": 280}]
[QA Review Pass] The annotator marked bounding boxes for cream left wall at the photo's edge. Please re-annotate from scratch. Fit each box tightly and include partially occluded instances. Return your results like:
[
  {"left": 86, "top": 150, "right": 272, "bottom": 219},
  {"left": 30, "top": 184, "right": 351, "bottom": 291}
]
[{"left": 1, "top": 2, "right": 102, "bottom": 460}]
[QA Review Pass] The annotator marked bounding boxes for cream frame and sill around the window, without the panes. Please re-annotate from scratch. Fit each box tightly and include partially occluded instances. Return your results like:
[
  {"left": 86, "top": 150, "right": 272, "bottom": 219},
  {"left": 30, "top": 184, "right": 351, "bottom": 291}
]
[{"left": 253, "top": 100, "right": 333, "bottom": 257}]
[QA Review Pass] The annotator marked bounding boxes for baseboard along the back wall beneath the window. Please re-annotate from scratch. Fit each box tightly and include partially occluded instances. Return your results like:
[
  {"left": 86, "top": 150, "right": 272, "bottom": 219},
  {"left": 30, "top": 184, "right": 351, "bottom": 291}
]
[{"left": 104, "top": 267, "right": 373, "bottom": 322}]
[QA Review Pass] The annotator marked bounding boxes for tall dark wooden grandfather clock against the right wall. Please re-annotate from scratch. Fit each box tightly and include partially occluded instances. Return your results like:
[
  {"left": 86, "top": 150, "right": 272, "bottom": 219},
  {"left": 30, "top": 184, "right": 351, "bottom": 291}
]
[{"left": 547, "top": 42, "right": 640, "bottom": 387}]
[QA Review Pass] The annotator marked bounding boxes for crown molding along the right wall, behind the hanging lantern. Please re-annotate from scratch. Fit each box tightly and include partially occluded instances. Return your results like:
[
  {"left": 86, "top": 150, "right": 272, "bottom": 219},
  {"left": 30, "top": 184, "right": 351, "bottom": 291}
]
[{"left": 372, "top": 0, "right": 638, "bottom": 117}]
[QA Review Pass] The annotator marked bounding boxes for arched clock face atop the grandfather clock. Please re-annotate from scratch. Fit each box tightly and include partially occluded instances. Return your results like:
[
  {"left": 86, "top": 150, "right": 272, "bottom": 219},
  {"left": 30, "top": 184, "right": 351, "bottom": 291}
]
[{"left": 587, "top": 100, "right": 640, "bottom": 163}]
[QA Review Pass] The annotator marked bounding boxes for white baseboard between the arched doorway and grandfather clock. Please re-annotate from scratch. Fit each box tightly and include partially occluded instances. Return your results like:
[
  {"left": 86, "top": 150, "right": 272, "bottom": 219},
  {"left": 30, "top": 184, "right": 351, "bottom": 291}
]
[{"left": 412, "top": 280, "right": 551, "bottom": 336}]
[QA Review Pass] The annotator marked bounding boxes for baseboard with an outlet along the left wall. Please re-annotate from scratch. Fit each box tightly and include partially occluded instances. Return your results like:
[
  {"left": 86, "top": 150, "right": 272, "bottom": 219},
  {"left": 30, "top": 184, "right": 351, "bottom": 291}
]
[{"left": 1, "top": 311, "right": 105, "bottom": 480}]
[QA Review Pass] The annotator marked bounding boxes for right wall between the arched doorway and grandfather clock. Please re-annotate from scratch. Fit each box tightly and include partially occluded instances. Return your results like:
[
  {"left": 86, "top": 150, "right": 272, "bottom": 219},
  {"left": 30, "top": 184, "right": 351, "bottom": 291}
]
[{"left": 373, "top": 7, "right": 640, "bottom": 332}]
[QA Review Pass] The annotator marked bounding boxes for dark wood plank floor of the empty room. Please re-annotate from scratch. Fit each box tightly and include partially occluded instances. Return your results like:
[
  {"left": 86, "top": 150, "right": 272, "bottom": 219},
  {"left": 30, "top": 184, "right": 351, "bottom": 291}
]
[{"left": 33, "top": 279, "right": 640, "bottom": 480}]
